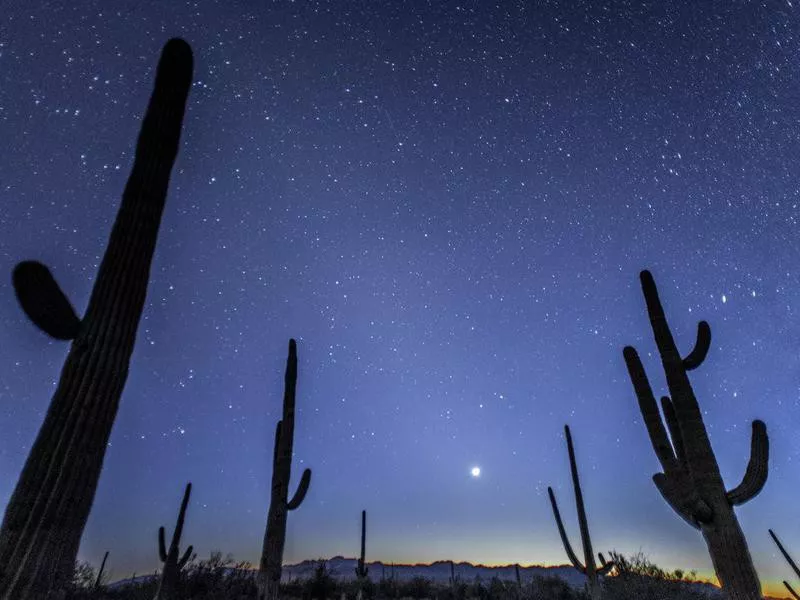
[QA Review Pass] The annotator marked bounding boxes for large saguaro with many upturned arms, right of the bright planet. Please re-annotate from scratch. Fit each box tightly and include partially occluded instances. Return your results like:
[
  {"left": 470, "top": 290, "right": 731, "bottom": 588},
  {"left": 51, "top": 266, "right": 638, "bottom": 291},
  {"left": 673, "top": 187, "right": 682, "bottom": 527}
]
[{"left": 624, "top": 271, "right": 769, "bottom": 600}]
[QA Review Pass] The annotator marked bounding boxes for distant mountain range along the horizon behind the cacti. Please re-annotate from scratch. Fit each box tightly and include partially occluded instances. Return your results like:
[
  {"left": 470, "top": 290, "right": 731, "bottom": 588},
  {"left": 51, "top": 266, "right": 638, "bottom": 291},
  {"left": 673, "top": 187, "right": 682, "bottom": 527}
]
[{"left": 108, "top": 556, "right": 752, "bottom": 600}]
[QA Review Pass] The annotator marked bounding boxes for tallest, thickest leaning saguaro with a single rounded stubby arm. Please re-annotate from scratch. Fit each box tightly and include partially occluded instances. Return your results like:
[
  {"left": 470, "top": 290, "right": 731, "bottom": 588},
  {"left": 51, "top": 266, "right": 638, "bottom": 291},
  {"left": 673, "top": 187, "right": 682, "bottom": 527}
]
[{"left": 0, "top": 39, "right": 192, "bottom": 600}]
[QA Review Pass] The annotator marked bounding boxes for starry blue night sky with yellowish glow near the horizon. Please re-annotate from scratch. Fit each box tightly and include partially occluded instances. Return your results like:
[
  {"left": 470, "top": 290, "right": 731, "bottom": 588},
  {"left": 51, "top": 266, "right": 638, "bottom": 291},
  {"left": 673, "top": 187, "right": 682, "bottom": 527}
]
[{"left": 0, "top": 0, "right": 800, "bottom": 591}]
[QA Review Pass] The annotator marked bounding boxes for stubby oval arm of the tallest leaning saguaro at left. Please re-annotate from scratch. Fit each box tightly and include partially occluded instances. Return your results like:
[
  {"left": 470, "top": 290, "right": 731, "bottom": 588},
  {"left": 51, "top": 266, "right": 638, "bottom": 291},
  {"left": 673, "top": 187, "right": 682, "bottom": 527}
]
[{"left": 12, "top": 260, "right": 81, "bottom": 340}]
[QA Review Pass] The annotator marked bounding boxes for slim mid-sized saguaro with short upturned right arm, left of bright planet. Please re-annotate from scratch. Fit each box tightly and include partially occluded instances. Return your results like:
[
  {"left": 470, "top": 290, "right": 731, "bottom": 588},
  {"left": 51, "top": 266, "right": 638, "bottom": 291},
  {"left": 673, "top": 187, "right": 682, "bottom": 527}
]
[{"left": 258, "top": 340, "right": 311, "bottom": 600}]
